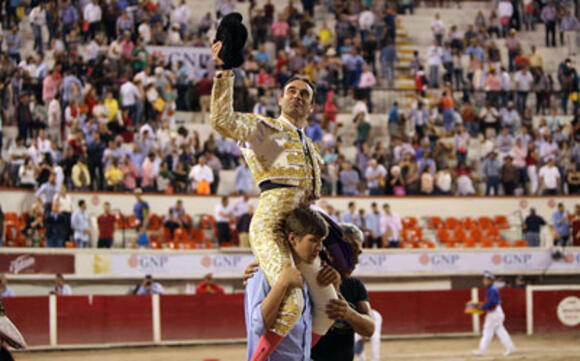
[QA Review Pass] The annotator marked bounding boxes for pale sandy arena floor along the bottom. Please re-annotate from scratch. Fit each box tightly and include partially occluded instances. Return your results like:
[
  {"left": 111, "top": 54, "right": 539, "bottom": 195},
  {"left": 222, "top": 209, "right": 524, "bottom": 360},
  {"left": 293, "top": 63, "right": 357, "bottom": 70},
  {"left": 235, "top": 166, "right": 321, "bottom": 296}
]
[{"left": 15, "top": 332, "right": 580, "bottom": 361}]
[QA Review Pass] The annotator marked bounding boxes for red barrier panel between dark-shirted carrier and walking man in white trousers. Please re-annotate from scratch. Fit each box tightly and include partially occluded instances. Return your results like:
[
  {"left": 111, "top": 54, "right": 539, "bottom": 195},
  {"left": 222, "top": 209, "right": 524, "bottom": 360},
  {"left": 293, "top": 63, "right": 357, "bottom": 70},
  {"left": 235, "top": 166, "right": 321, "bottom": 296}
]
[{"left": 369, "top": 290, "right": 473, "bottom": 335}]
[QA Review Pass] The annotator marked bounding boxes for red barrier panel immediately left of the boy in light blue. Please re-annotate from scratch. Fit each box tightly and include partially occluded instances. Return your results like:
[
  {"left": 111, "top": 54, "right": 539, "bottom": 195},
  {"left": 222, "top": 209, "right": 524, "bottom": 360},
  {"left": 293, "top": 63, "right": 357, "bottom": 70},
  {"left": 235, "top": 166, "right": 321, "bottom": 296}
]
[{"left": 160, "top": 294, "right": 246, "bottom": 340}]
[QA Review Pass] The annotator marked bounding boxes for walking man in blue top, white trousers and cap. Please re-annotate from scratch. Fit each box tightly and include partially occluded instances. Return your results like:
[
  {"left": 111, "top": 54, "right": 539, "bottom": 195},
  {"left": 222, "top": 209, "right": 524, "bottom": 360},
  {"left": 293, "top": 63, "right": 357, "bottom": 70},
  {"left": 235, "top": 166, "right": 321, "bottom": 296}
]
[{"left": 473, "top": 271, "right": 516, "bottom": 356}]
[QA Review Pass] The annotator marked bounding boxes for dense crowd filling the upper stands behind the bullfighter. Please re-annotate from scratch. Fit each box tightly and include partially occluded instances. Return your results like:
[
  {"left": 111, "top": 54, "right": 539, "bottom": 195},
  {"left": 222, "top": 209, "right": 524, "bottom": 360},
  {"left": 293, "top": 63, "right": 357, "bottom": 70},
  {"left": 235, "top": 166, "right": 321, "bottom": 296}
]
[{"left": 0, "top": 0, "right": 580, "bottom": 202}]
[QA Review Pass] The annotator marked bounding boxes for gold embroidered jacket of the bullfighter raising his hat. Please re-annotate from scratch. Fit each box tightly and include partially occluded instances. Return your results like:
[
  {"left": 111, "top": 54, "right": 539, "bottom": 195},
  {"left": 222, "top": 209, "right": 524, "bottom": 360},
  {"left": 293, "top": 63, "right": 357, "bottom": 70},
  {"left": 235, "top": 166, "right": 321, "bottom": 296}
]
[{"left": 209, "top": 76, "right": 322, "bottom": 198}]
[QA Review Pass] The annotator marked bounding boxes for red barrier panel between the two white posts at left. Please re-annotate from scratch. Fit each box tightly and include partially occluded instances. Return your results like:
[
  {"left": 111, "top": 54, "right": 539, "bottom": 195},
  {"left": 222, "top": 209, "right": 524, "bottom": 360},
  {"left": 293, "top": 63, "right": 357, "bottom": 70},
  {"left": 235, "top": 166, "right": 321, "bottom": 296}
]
[{"left": 57, "top": 296, "right": 153, "bottom": 344}]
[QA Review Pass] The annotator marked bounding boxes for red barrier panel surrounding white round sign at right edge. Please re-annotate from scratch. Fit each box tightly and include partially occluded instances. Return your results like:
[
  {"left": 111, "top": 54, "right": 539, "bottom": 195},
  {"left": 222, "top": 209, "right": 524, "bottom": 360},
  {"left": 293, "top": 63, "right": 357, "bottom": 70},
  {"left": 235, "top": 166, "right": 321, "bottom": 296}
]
[{"left": 532, "top": 290, "right": 580, "bottom": 333}]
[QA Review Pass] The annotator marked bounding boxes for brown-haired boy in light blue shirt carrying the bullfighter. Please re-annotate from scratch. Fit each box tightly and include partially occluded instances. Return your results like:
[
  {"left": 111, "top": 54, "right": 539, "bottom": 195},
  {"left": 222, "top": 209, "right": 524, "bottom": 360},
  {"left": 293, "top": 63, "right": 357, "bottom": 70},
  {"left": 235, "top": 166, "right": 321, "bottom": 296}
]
[{"left": 244, "top": 208, "right": 339, "bottom": 361}]
